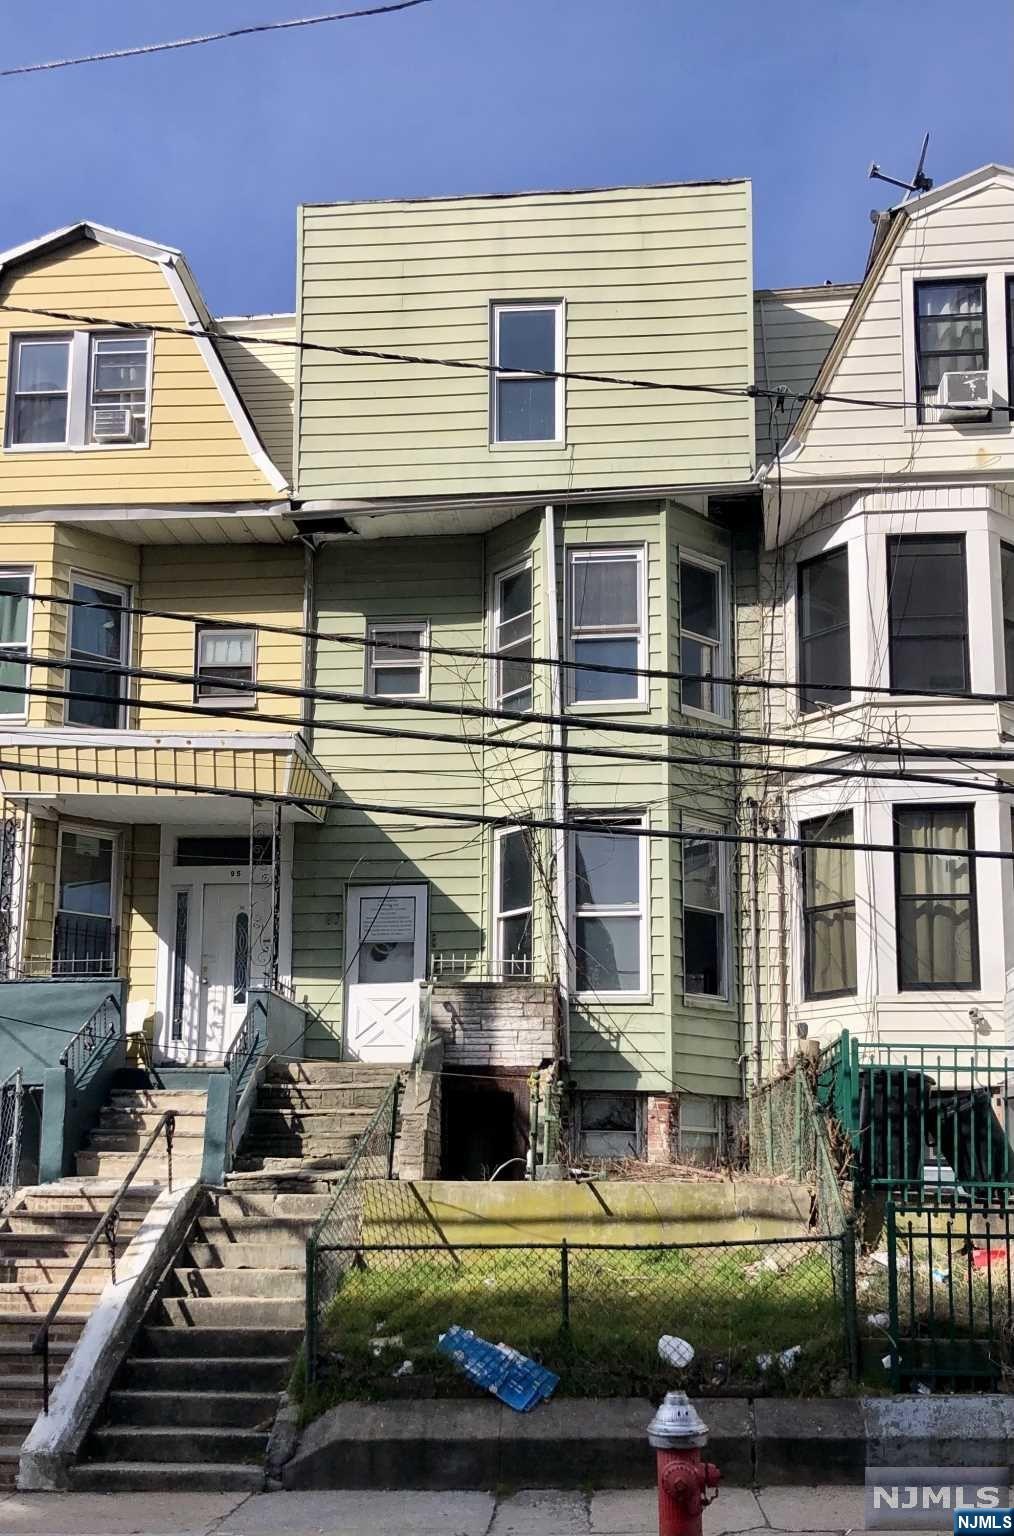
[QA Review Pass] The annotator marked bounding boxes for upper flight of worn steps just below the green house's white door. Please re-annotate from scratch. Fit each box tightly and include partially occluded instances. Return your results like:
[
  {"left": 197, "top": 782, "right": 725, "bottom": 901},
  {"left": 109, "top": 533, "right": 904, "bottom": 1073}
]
[{"left": 235, "top": 1061, "right": 398, "bottom": 1174}]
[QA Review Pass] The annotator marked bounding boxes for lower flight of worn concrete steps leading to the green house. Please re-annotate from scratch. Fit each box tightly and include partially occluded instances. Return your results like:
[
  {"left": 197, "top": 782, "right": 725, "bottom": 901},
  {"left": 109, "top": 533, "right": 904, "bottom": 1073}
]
[{"left": 71, "top": 1175, "right": 330, "bottom": 1491}]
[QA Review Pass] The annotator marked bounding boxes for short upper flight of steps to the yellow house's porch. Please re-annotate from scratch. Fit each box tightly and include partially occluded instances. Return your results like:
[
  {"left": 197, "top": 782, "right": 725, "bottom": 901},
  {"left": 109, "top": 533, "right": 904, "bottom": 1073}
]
[{"left": 75, "top": 1084, "right": 207, "bottom": 1184}]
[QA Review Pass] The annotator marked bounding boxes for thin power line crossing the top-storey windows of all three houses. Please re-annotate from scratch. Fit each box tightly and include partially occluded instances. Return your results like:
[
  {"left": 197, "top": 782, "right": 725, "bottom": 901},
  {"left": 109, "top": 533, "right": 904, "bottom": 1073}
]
[{"left": 0, "top": 302, "right": 995, "bottom": 416}]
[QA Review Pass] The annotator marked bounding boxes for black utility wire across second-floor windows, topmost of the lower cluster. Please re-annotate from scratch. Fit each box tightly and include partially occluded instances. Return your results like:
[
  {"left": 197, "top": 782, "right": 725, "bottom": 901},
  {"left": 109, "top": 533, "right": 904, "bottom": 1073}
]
[{"left": 17, "top": 576, "right": 1014, "bottom": 720}]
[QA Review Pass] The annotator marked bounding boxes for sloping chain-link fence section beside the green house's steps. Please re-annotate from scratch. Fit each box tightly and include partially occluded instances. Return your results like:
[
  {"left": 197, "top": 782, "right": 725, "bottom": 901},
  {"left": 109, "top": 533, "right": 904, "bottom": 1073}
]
[{"left": 306, "top": 1077, "right": 403, "bottom": 1382}]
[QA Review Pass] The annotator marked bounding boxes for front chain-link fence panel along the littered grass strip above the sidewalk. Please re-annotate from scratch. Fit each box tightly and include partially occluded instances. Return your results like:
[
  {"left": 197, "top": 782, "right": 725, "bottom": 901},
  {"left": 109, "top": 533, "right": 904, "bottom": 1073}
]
[{"left": 313, "top": 1223, "right": 856, "bottom": 1410}]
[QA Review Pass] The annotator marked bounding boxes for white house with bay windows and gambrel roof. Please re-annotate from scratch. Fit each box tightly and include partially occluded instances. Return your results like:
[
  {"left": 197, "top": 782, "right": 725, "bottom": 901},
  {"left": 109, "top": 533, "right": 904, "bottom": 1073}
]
[{"left": 749, "top": 166, "right": 1014, "bottom": 1072}]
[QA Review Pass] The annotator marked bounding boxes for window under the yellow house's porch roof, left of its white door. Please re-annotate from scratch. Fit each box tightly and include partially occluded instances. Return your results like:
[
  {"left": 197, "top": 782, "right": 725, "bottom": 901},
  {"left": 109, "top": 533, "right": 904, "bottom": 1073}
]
[{"left": 52, "top": 828, "right": 117, "bottom": 975}]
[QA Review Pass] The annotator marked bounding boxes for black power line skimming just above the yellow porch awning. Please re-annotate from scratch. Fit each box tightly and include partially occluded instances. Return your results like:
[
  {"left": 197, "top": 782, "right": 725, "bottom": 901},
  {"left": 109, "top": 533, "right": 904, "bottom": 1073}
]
[{"left": 0, "top": 662, "right": 1014, "bottom": 794}]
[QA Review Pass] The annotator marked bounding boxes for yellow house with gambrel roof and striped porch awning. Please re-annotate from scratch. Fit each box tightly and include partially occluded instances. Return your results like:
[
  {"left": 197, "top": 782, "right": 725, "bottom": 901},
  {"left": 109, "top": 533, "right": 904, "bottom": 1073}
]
[{"left": 0, "top": 224, "right": 332, "bottom": 1061}]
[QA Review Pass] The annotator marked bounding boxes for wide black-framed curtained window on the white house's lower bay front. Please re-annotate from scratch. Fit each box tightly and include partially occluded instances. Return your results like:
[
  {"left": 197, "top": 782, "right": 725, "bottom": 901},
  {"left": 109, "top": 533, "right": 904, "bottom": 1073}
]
[{"left": 894, "top": 805, "right": 979, "bottom": 991}]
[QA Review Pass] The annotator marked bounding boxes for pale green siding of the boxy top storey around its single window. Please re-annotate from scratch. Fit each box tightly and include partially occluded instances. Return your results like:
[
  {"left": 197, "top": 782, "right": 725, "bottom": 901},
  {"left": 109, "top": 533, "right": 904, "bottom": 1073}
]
[{"left": 297, "top": 181, "right": 753, "bottom": 498}]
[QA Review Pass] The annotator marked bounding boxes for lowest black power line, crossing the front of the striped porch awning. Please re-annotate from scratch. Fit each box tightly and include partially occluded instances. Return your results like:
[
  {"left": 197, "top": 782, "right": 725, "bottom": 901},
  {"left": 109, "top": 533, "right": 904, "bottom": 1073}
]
[{"left": 0, "top": 757, "right": 1014, "bottom": 863}]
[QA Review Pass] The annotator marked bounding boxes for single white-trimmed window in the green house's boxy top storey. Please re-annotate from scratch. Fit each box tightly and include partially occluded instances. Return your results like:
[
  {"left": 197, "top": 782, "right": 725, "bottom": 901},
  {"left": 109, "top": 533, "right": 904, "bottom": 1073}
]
[{"left": 490, "top": 301, "right": 564, "bottom": 442}]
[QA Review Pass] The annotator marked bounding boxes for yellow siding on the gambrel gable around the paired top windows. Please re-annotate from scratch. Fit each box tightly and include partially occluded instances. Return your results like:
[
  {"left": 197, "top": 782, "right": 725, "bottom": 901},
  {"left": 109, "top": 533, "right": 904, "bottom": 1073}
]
[{"left": 0, "top": 240, "right": 278, "bottom": 507}]
